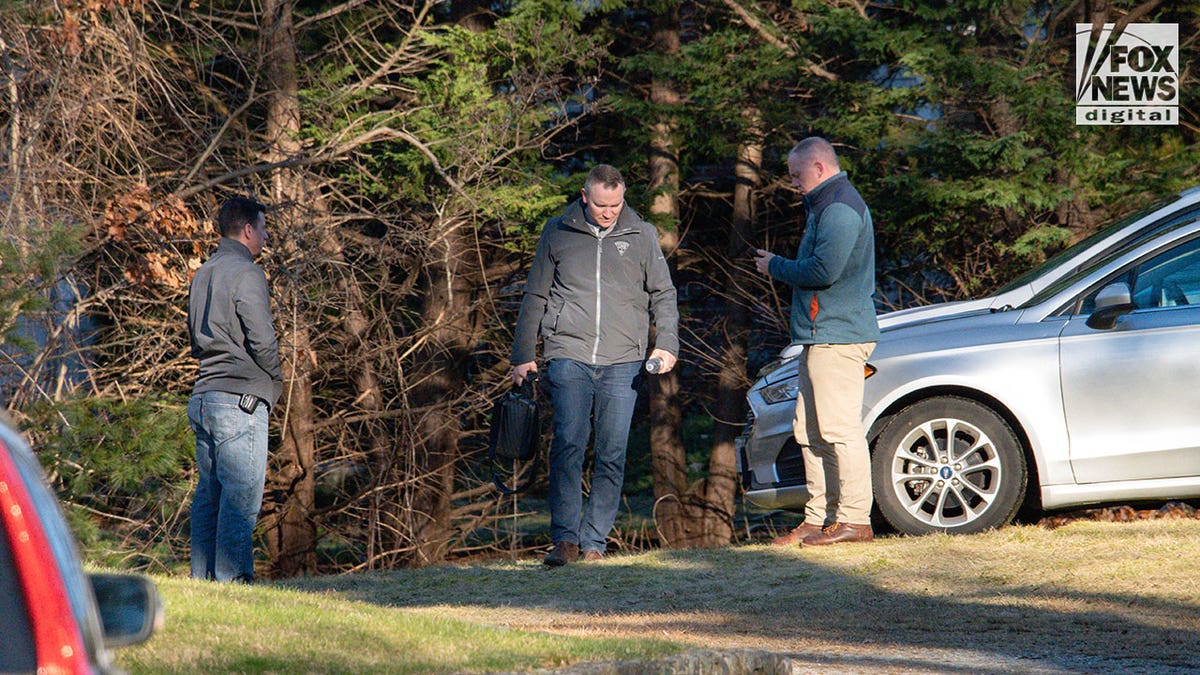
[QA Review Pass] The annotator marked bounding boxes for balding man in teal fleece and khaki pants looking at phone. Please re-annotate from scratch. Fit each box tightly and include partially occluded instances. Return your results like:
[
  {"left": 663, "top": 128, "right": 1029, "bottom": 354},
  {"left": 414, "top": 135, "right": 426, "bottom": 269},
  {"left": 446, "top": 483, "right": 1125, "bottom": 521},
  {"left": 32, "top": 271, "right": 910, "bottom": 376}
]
[{"left": 755, "top": 137, "right": 880, "bottom": 546}]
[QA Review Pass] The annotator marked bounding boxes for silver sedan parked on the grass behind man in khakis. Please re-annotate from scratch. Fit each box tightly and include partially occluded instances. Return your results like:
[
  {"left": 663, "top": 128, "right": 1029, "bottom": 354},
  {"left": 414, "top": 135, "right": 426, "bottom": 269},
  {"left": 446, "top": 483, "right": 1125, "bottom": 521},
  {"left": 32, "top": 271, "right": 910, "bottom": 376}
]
[{"left": 738, "top": 216, "right": 1200, "bottom": 534}]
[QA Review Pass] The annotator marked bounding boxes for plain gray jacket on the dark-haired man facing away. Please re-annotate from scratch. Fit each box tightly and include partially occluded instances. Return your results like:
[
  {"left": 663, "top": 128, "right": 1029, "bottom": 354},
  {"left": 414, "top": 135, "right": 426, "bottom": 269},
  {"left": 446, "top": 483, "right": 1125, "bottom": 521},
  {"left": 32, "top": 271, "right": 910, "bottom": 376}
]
[{"left": 187, "top": 237, "right": 283, "bottom": 407}]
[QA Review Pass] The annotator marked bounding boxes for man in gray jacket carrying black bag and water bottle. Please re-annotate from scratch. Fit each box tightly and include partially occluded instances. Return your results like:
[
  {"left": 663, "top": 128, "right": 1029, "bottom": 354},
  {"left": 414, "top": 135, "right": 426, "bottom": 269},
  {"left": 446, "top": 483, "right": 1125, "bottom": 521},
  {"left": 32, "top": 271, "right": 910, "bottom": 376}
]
[{"left": 510, "top": 165, "right": 679, "bottom": 567}]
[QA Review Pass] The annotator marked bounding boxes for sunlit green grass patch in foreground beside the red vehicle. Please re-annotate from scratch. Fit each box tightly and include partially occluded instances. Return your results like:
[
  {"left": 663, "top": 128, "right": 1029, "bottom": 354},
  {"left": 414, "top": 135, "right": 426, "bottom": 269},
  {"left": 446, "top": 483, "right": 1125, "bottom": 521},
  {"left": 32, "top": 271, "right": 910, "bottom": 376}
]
[{"left": 118, "top": 571, "right": 682, "bottom": 674}]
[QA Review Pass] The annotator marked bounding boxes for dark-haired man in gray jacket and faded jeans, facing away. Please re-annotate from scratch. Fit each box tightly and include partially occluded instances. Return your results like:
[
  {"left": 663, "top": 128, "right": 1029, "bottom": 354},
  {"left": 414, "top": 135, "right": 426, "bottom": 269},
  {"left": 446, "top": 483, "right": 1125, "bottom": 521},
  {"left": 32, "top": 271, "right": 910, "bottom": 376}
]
[{"left": 187, "top": 197, "right": 283, "bottom": 584}]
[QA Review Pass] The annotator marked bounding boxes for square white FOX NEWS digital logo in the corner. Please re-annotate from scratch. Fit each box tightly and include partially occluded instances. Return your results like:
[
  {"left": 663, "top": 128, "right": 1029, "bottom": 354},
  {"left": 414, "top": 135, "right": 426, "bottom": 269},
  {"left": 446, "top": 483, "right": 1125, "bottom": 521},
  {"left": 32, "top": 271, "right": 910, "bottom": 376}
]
[{"left": 1075, "top": 24, "right": 1180, "bottom": 125}]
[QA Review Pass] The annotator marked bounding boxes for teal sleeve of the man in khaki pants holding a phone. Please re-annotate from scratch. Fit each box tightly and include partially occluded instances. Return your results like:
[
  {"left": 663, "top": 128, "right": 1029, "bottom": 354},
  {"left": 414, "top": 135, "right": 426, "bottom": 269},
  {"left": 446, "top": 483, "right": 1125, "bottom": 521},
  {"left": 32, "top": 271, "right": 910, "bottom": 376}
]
[{"left": 768, "top": 204, "right": 863, "bottom": 288}]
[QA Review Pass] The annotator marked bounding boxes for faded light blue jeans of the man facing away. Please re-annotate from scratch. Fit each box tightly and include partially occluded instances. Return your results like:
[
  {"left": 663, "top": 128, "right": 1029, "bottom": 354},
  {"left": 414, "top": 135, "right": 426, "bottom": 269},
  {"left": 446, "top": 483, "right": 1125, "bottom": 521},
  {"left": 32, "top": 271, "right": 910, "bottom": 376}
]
[{"left": 187, "top": 392, "right": 268, "bottom": 581}]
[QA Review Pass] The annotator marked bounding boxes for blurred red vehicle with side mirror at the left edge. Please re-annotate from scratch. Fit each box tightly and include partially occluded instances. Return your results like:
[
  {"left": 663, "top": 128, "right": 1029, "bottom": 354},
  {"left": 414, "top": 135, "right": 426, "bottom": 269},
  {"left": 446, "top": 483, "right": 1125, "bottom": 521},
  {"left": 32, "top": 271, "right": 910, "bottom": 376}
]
[{"left": 0, "top": 422, "right": 162, "bottom": 675}]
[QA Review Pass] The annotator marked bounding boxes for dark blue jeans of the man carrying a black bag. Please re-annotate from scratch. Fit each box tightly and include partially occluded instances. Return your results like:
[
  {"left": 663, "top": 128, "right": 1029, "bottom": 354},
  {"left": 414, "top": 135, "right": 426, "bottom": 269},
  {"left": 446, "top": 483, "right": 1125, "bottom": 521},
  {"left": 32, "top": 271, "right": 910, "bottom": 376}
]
[{"left": 546, "top": 359, "right": 642, "bottom": 552}]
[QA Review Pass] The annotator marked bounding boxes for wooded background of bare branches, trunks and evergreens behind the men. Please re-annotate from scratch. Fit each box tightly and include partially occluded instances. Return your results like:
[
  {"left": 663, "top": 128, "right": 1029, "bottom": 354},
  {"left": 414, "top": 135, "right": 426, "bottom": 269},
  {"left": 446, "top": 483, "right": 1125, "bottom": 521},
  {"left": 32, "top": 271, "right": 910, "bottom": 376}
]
[{"left": 0, "top": 0, "right": 1200, "bottom": 575}]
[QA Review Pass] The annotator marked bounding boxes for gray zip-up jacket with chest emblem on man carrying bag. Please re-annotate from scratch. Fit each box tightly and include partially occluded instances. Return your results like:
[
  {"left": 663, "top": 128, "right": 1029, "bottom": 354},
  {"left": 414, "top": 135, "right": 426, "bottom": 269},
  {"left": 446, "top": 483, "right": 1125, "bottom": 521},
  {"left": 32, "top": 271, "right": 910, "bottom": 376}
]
[{"left": 509, "top": 201, "right": 679, "bottom": 365}]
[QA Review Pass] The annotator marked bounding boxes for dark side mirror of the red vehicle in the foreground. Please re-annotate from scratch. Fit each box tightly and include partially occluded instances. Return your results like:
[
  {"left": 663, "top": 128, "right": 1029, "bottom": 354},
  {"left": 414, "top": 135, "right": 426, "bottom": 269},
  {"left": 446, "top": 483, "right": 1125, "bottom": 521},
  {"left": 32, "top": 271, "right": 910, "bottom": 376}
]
[{"left": 88, "top": 574, "right": 163, "bottom": 649}]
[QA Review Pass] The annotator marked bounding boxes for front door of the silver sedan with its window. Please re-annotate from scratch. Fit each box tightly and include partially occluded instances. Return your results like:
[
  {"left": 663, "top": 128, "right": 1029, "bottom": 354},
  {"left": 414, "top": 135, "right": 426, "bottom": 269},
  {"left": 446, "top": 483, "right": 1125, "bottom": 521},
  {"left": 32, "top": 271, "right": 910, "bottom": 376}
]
[{"left": 1060, "top": 238, "right": 1200, "bottom": 483}]
